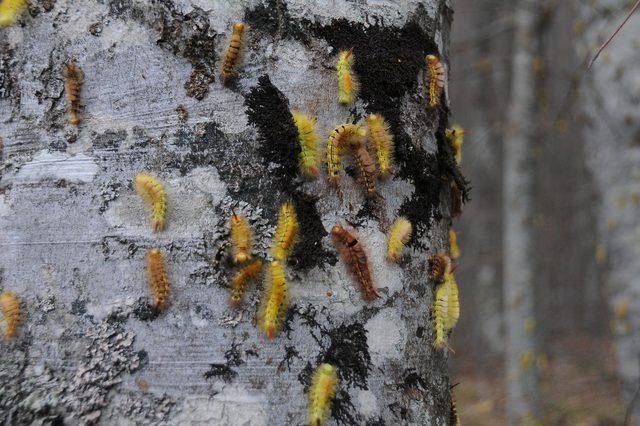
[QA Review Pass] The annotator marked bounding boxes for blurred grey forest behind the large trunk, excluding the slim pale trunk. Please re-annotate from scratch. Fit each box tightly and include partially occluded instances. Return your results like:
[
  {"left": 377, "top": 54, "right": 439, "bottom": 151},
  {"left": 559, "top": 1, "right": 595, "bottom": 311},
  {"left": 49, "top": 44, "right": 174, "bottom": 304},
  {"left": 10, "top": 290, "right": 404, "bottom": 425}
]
[{"left": 449, "top": 0, "right": 640, "bottom": 425}]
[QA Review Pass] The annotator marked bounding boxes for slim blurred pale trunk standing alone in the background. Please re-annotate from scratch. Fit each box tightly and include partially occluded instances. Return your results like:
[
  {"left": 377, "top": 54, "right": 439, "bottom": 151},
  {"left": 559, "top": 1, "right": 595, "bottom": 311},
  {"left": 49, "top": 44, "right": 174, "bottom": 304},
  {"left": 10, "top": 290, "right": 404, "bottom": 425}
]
[{"left": 503, "top": 0, "right": 539, "bottom": 424}]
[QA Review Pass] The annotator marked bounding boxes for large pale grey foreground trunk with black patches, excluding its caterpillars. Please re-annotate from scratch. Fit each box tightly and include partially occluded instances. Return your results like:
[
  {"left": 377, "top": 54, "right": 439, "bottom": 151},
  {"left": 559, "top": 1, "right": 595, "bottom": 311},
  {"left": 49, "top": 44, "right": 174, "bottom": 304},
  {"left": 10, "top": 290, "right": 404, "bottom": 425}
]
[{"left": 0, "top": 0, "right": 462, "bottom": 425}]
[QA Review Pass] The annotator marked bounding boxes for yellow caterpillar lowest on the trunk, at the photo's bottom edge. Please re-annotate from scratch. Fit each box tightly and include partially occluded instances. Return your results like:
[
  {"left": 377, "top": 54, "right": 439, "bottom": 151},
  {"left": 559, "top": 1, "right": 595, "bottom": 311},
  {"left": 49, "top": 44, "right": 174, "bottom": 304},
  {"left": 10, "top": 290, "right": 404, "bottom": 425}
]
[{"left": 309, "top": 363, "right": 339, "bottom": 426}]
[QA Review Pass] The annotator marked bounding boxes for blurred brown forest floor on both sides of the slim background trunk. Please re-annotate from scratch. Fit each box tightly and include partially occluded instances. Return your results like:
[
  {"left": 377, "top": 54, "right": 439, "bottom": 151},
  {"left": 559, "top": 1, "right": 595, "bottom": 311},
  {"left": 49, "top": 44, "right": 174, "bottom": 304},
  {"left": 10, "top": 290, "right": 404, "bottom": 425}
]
[{"left": 453, "top": 337, "right": 626, "bottom": 426}]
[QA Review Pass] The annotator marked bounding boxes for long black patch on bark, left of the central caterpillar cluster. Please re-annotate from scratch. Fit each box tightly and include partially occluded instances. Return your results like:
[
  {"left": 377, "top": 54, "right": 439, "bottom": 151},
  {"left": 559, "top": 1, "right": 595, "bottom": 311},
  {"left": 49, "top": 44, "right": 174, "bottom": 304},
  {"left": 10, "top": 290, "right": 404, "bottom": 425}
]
[{"left": 245, "top": 75, "right": 337, "bottom": 271}]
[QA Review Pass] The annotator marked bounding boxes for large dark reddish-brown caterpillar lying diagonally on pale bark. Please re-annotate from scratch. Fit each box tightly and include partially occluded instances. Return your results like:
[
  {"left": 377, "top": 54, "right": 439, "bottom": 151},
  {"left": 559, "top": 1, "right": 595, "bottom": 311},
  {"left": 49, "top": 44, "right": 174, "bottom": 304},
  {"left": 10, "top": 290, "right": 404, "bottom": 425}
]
[{"left": 331, "top": 225, "right": 380, "bottom": 300}]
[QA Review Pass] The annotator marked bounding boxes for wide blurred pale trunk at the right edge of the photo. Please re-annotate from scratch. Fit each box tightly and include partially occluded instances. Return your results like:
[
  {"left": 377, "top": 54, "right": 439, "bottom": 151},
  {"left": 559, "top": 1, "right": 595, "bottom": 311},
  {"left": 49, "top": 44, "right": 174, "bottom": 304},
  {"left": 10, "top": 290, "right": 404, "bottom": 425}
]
[{"left": 577, "top": 0, "right": 640, "bottom": 424}]
